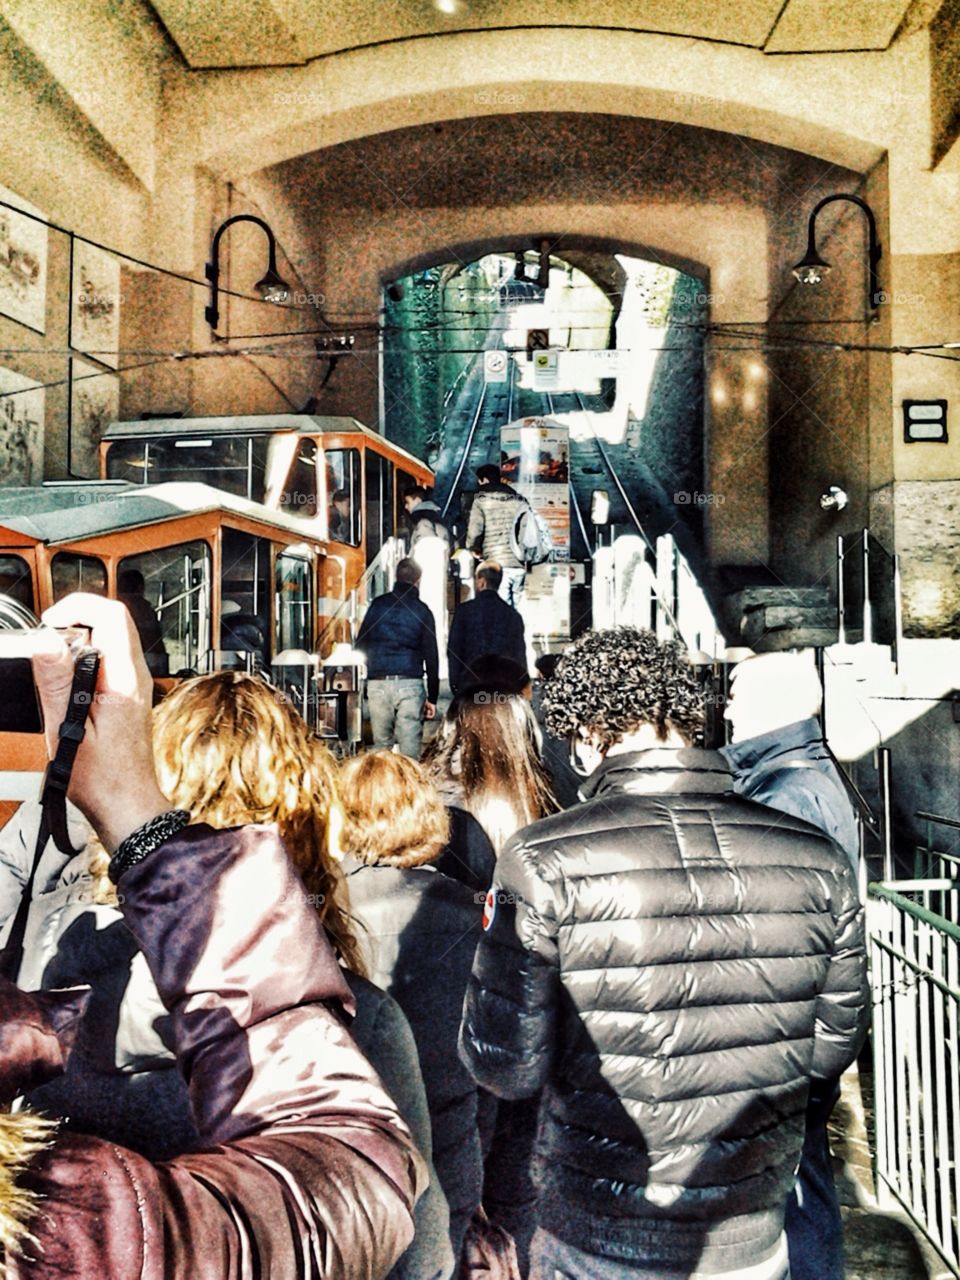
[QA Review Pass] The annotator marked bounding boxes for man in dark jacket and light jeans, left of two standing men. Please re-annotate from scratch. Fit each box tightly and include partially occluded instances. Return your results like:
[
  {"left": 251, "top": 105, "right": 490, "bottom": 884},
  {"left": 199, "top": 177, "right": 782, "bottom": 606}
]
[{"left": 356, "top": 558, "right": 440, "bottom": 760}]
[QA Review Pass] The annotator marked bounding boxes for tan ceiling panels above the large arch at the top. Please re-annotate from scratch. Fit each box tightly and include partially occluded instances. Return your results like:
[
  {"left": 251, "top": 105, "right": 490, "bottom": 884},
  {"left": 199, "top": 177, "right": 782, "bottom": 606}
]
[{"left": 151, "top": 0, "right": 937, "bottom": 69}]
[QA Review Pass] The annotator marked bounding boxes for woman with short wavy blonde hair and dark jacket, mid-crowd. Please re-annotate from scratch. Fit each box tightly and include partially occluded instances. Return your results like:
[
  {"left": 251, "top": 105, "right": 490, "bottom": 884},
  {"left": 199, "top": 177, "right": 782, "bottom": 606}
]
[{"left": 340, "top": 750, "right": 489, "bottom": 1258}]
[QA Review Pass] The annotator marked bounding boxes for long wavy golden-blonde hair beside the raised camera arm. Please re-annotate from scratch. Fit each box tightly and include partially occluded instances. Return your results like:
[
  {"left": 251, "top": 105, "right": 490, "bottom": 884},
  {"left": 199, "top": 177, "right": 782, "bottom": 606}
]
[{"left": 154, "top": 671, "right": 366, "bottom": 974}]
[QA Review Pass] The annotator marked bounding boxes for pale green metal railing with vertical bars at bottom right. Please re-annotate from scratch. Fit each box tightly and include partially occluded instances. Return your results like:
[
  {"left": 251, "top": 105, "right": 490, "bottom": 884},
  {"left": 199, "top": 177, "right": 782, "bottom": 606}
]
[{"left": 867, "top": 878, "right": 960, "bottom": 1276}]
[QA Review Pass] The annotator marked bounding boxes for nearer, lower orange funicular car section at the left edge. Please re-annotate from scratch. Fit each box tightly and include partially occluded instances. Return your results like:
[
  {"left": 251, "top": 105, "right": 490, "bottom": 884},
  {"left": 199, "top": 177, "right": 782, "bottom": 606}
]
[{"left": 0, "top": 481, "right": 335, "bottom": 824}]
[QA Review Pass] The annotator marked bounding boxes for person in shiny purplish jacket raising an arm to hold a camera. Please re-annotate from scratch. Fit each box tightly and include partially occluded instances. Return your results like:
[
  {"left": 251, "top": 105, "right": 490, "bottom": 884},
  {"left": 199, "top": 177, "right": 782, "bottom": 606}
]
[{"left": 0, "top": 594, "right": 424, "bottom": 1280}]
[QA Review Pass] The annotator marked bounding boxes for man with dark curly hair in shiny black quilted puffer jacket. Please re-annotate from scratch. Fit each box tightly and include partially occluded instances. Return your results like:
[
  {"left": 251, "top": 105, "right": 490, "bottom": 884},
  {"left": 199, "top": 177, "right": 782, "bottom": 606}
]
[{"left": 461, "top": 627, "right": 868, "bottom": 1280}]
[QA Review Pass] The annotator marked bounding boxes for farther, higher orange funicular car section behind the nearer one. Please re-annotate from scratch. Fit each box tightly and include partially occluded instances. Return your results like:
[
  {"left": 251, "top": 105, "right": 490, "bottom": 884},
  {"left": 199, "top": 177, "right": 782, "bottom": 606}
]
[{"left": 100, "top": 413, "right": 434, "bottom": 639}]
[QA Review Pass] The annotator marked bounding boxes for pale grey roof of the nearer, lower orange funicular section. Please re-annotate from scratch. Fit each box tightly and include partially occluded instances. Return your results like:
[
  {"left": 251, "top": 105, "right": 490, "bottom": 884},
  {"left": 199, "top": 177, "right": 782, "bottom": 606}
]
[{"left": 0, "top": 480, "right": 323, "bottom": 545}]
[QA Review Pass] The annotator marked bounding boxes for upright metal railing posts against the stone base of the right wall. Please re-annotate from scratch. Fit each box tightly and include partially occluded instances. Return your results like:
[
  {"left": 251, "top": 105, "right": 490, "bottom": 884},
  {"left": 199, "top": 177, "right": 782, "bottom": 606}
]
[{"left": 837, "top": 529, "right": 904, "bottom": 667}]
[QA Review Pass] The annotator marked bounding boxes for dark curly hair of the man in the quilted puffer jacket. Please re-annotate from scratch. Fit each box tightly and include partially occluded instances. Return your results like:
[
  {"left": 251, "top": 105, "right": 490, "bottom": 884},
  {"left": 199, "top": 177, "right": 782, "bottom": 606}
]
[{"left": 543, "top": 627, "right": 704, "bottom": 746}]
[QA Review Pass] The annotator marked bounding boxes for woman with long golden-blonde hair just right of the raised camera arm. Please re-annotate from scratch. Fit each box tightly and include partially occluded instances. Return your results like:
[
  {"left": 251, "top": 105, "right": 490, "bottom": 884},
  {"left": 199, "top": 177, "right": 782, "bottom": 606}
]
[{"left": 154, "top": 671, "right": 455, "bottom": 1280}]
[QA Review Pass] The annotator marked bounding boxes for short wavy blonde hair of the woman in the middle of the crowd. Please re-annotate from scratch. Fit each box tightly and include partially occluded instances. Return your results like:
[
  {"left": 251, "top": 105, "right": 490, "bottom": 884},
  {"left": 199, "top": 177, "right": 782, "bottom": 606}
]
[{"left": 340, "top": 750, "right": 451, "bottom": 868}]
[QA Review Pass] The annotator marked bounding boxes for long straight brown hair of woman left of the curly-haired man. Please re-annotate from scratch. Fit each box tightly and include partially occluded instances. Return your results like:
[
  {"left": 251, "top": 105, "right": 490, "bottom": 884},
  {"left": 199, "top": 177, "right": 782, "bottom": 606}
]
[{"left": 424, "top": 691, "right": 559, "bottom": 852}]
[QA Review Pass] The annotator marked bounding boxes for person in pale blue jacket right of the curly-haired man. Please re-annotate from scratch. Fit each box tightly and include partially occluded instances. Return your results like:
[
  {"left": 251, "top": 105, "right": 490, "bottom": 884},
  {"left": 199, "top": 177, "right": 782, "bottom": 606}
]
[{"left": 721, "top": 649, "right": 860, "bottom": 1280}]
